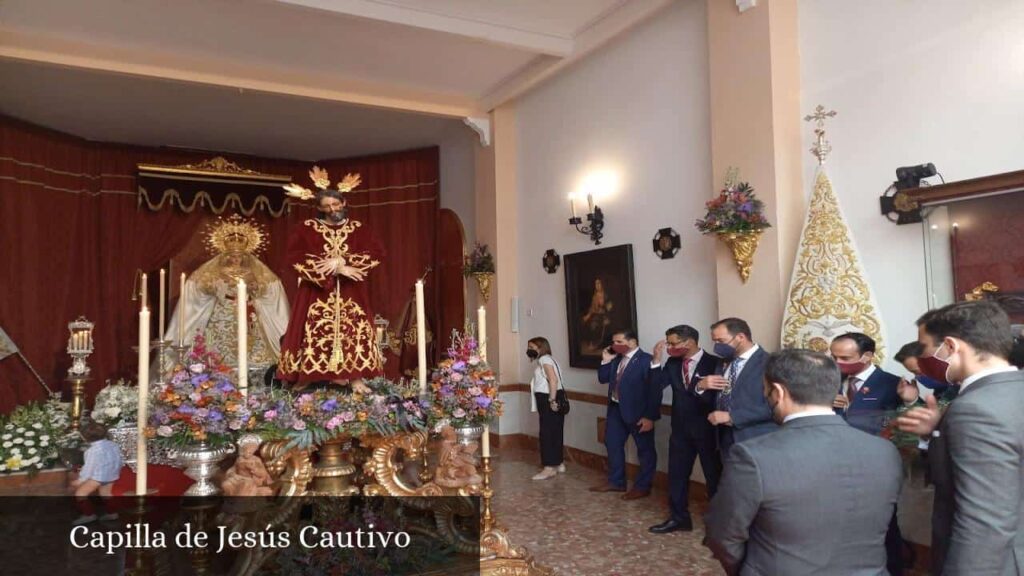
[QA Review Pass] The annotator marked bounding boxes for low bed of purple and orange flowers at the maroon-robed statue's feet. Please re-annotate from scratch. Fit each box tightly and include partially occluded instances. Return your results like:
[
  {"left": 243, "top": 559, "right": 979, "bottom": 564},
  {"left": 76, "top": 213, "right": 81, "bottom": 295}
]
[{"left": 249, "top": 378, "right": 426, "bottom": 449}]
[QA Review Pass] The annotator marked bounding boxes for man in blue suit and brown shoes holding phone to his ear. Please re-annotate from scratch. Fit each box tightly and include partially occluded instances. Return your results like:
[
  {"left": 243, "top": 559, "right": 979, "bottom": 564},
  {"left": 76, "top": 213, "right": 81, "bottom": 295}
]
[{"left": 590, "top": 329, "right": 662, "bottom": 500}]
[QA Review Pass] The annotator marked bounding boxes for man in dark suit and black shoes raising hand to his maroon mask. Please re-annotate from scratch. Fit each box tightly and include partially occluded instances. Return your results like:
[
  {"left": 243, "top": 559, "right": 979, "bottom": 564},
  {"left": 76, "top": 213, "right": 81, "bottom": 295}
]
[{"left": 648, "top": 325, "right": 722, "bottom": 534}]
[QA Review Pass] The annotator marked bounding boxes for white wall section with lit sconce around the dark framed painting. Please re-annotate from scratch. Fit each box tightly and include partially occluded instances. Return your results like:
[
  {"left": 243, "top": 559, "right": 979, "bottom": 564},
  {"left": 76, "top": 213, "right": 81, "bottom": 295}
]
[{"left": 501, "top": 0, "right": 717, "bottom": 469}]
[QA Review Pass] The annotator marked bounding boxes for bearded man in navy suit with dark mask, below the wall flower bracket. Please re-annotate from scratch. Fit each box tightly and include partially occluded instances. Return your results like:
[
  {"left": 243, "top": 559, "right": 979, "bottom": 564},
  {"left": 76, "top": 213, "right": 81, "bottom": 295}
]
[{"left": 697, "top": 318, "right": 778, "bottom": 457}]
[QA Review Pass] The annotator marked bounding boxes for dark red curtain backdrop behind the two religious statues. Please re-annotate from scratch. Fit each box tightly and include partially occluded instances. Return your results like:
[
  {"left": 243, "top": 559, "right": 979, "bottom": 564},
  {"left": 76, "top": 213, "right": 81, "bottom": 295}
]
[{"left": 0, "top": 117, "right": 438, "bottom": 413}]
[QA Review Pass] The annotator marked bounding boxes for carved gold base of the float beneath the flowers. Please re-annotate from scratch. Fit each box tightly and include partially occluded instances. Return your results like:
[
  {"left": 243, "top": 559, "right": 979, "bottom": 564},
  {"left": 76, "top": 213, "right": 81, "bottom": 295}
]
[{"left": 260, "top": 424, "right": 553, "bottom": 576}]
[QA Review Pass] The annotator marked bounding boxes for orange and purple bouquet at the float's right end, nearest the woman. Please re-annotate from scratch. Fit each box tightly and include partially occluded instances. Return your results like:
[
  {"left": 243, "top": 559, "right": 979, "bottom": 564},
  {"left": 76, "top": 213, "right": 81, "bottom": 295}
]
[{"left": 430, "top": 333, "right": 502, "bottom": 429}]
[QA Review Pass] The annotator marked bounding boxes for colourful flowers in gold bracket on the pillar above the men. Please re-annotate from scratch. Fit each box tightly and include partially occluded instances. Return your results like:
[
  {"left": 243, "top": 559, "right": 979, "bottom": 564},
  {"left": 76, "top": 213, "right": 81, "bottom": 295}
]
[{"left": 696, "top": 168, "right": 771, "bottom": 284}]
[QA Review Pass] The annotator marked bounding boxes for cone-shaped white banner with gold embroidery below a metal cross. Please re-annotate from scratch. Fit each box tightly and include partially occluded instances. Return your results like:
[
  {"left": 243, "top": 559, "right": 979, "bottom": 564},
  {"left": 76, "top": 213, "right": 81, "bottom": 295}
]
[{"left": 782, "top": 168, "right": 885, "bottom": 360}]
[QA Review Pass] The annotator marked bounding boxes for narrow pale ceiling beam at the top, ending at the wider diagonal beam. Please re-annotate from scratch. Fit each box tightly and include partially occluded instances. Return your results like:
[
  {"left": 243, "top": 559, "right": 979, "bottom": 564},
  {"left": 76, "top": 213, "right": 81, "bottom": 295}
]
[{"left": 276, "top": 0, "right": 572, "bottom": 56}]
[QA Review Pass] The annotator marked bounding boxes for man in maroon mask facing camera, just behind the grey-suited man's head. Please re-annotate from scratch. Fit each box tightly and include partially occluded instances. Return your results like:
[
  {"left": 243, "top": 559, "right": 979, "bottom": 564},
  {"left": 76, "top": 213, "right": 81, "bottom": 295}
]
[{"left": 829, "top": 332, "right": 900, "bottom": 436}]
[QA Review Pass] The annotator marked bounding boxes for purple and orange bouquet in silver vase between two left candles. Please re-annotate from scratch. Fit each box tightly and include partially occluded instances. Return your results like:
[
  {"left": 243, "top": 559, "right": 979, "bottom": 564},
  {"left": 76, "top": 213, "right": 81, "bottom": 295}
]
[{"left": 145, "top": 334, "right": 256, "bottom": 447}]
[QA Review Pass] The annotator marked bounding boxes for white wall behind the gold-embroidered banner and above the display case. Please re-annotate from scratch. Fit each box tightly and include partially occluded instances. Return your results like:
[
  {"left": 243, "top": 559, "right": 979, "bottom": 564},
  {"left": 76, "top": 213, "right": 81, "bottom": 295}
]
[{"left": 800, "top": 0, "right": 1024, "bottom": 373}]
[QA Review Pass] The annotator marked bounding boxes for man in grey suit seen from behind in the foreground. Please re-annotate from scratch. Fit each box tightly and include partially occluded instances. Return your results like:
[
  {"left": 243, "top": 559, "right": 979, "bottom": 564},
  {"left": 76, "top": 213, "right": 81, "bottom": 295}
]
[{"left": 705, "top": 349, "right": 902, "bottom": 576}]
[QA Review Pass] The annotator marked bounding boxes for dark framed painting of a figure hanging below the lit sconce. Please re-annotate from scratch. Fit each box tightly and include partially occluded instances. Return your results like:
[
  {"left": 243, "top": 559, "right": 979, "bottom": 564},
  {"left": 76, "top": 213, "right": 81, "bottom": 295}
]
[{"left": 562, "top": 244, "right": 637, "bottom": 368}]
